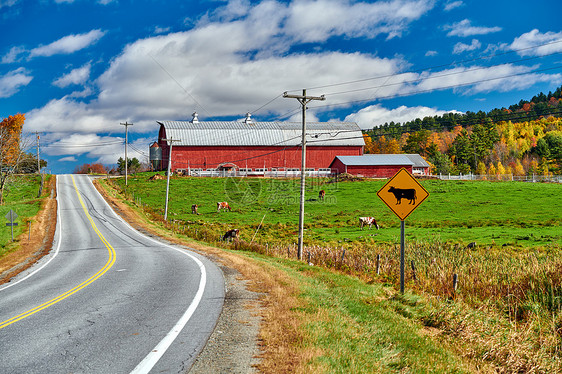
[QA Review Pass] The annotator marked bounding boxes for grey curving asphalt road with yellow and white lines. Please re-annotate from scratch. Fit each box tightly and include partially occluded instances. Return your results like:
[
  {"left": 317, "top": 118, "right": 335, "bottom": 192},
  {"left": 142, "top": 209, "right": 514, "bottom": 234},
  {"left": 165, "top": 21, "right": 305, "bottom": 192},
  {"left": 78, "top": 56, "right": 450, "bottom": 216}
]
[{"left": 0, "top": 175, "right": 224, "bottom": 374}]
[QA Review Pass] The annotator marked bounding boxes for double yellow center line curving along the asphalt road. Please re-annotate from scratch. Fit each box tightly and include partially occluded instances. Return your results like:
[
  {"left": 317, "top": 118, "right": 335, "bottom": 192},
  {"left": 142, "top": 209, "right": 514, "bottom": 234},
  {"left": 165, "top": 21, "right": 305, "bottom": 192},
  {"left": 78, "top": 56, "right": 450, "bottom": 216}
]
[{"left": 0, "top": 176, "right": 115, "bottom": 329}]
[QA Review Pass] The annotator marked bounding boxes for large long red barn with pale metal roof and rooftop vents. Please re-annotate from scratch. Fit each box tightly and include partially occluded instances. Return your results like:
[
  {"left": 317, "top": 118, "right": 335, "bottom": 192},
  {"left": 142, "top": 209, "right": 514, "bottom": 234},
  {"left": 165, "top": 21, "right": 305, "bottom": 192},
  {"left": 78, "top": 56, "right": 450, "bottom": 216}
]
[{"left": 157, "top": 113, "right": 365, "bottom": 171}]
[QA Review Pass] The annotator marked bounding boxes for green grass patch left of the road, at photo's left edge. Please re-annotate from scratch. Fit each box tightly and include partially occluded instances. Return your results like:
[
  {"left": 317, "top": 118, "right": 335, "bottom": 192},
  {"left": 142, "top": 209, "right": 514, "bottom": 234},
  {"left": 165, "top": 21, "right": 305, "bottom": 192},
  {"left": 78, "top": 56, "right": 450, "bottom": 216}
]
[{"left": 0, "top": 174, "right": 46, "bottom": 257}]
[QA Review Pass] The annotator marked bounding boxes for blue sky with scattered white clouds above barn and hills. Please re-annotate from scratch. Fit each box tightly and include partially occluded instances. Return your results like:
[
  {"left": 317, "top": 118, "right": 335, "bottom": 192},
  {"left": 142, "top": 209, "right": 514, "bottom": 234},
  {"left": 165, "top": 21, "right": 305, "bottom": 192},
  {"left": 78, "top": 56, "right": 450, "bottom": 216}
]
[{"left": 0, "top": 0, "right": 562, "bottom": 173}]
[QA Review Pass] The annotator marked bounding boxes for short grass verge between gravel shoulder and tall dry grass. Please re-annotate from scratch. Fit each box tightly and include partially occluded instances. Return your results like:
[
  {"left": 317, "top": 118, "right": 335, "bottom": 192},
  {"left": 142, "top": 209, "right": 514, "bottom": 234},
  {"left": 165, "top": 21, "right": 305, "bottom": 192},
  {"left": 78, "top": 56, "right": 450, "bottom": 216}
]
[{"left": 243, "top": 252, "right": 472, "bottom": 373}]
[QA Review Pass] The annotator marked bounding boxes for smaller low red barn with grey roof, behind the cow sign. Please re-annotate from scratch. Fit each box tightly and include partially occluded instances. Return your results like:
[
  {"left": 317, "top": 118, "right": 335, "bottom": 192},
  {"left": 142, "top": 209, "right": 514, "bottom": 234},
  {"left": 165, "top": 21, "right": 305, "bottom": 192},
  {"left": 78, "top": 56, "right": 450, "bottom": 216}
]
[{"left": 330, "top": 154, "right": 422, "bottom": 178}]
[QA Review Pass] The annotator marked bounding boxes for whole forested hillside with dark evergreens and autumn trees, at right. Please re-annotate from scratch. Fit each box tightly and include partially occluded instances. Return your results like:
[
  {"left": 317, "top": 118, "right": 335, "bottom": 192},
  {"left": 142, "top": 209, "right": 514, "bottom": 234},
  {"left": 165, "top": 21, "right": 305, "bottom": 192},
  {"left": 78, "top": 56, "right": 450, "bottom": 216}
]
[{"left": 365, "top": 87, "right": 562, "bottom": 175}]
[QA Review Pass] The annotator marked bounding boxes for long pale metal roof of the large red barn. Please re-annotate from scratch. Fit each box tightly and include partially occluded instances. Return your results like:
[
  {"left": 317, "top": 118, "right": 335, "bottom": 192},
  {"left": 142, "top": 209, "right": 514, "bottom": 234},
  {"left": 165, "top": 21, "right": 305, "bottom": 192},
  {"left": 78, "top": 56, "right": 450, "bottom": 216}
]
[{"left": 157, "top": 121, "right": 365, "bottom": 147}]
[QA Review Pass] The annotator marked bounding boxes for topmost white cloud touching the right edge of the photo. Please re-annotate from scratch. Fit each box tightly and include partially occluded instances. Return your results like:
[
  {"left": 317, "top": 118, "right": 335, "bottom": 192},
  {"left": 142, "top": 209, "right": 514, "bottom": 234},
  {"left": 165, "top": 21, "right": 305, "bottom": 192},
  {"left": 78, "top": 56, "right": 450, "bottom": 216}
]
[{"left": 508, "top": 29, "right": 562, "bottom": 56}]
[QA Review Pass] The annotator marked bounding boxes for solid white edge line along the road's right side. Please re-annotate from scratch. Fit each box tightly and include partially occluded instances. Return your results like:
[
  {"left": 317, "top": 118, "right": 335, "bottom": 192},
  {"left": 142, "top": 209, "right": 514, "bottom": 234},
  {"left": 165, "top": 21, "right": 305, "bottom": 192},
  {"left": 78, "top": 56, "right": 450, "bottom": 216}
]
[{"left": 86, "top": 179, "right": 207, "bottom": 374}]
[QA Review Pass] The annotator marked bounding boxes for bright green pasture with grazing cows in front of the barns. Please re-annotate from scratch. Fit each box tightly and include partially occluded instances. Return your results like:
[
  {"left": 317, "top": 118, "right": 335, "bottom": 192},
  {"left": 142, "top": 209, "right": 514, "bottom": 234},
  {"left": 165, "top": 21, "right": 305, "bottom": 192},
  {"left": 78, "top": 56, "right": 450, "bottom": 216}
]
[{"left": 111, "top": 173, "right": 562, "bottom": 247}]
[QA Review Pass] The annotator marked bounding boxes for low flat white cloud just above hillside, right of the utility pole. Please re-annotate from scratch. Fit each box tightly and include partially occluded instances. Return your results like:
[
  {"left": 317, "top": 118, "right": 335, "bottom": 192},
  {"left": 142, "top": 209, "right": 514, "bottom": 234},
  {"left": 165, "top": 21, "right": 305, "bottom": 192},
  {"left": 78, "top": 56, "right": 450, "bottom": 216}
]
[{"left": 345, "top": 104, "right": 460, "bottom": 129}]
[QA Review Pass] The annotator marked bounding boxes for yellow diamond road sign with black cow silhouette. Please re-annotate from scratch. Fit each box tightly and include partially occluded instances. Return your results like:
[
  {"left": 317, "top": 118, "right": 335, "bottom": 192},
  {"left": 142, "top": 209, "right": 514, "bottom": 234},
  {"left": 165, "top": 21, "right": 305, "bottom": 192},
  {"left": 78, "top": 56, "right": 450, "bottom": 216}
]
[{"left": 377, "top": 168, "right": 429, "bottom": 221}]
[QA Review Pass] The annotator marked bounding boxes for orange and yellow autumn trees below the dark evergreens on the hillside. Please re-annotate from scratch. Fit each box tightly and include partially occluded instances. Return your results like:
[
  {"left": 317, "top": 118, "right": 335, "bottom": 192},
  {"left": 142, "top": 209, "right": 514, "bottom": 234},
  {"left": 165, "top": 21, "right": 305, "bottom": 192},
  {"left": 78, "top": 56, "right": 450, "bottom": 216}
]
[{"left": 366, "top": 114, "right": 562, "bottom": 175}]
